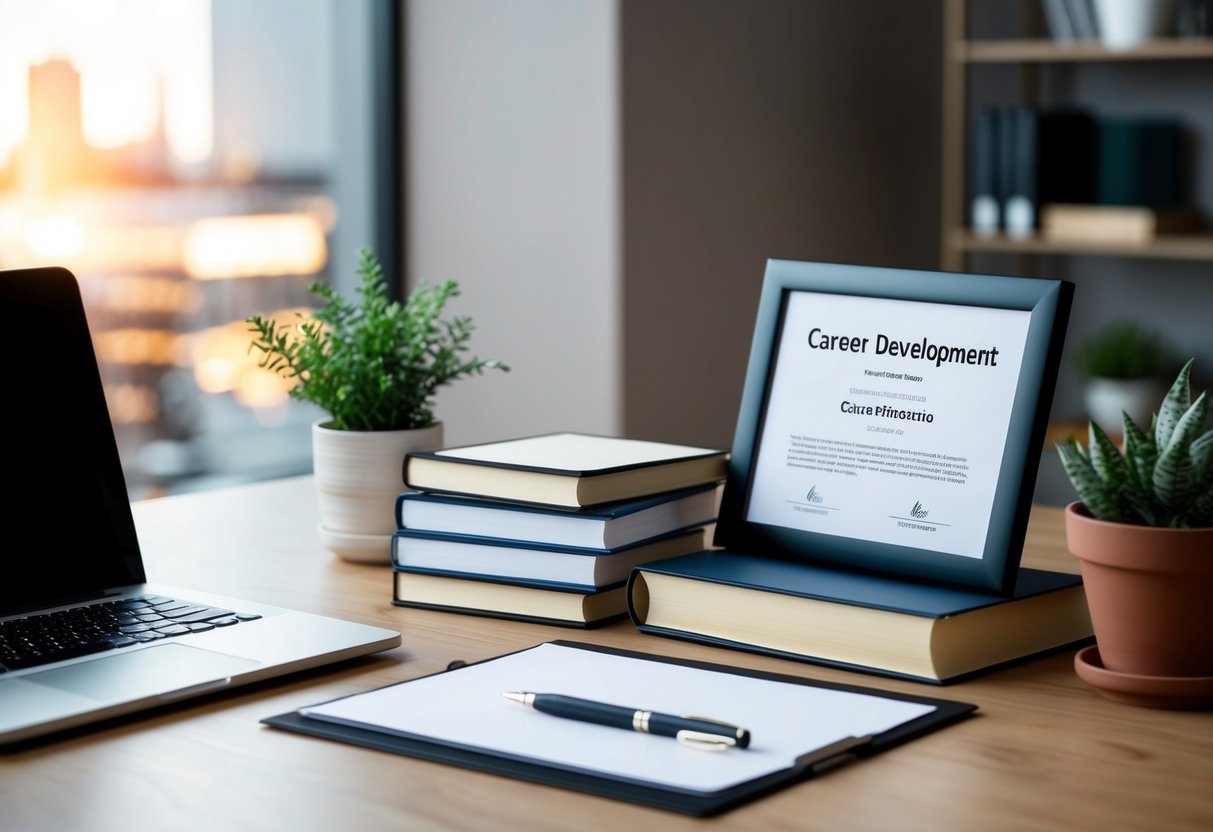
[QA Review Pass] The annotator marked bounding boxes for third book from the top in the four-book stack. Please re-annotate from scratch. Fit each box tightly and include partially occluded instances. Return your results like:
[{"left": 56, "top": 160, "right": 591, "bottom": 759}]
[{"left": 392, "top": 528, "right": 705, "bottom": 589}]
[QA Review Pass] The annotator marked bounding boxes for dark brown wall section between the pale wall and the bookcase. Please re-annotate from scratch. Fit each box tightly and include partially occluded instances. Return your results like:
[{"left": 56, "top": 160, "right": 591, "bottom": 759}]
[{"left": 621, "top": 0, "right": 943, "bottom": 446}]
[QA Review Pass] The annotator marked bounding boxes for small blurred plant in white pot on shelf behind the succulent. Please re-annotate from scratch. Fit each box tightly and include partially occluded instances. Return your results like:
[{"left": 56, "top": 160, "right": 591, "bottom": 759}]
[{"left": 1074, "top": 320, "right": 1173, "bottom": 435}]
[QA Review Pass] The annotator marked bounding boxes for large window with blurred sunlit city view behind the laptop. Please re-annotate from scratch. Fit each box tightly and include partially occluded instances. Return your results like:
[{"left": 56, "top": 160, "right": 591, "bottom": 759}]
[{"left": 0, "top": 0, "right": 400, "bottom": 497}]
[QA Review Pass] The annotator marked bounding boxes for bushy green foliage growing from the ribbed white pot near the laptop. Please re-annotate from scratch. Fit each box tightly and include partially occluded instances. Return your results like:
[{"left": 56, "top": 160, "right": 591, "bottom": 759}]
[{"left": 247, "top": 246, "right": 509, "bottom": 431}]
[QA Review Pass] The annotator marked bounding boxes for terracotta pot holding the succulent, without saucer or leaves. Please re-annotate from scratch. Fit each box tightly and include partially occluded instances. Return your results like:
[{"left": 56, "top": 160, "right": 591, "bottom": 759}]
[{"left": 1065, "top": 502, "right": 1213, "bottom": 677}]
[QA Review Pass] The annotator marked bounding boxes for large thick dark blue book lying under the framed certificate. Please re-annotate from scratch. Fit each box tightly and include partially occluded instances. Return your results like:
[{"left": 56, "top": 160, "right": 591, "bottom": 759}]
[{"left": 627, "top": 551, "right": 1092, "bottom": 684}]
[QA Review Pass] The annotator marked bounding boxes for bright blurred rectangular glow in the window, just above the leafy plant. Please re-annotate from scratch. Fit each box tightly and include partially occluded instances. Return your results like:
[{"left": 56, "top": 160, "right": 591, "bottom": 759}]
[{"left": 184, "top": 213, "right": 329, "bottom": 280}]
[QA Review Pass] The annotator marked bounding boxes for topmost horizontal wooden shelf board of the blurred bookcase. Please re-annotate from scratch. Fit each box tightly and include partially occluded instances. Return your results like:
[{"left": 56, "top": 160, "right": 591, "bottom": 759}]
[{"left": 951, "top": 38, "right": 1213, "bottom": 63}]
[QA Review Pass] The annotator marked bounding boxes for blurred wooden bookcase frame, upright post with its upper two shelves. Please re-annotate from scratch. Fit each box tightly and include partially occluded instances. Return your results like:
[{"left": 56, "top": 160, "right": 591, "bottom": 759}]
[{"left": 940, "top": 0, "right": 1213, "bottom": 270}]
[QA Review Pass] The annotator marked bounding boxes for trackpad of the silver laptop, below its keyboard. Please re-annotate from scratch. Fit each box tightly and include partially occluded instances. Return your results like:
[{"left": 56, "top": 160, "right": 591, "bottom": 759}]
[{"left": 23, "top": 644, "right": 257, "bottom": 702}]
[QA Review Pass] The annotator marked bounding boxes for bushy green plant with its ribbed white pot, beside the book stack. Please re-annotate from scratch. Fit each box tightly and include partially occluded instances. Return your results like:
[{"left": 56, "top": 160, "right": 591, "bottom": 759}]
[{"left": 247, "top": 246, "right": 508, "bottom": 564}]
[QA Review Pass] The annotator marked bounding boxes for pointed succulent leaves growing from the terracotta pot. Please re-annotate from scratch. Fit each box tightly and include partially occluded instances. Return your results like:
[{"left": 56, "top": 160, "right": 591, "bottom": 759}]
[{"left": 1058, "top": 359, "right": 1213, "bottom": 528}]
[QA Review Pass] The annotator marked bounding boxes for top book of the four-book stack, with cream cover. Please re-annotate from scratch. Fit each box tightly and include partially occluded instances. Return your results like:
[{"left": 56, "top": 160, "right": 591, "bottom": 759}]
[{"left": 403, "top": 433, "right": 728, "bottom": 508}]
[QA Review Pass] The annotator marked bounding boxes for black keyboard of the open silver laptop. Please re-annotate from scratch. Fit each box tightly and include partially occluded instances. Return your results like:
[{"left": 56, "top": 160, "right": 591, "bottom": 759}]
[{"left": 0, "top": 595, "right": 261, "bottom": 672}]
